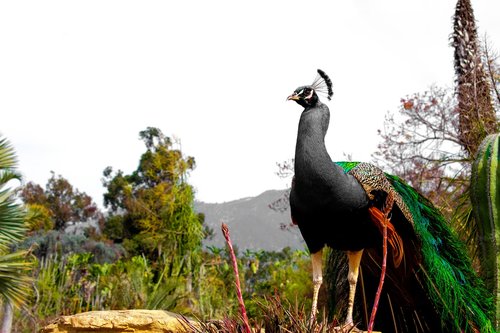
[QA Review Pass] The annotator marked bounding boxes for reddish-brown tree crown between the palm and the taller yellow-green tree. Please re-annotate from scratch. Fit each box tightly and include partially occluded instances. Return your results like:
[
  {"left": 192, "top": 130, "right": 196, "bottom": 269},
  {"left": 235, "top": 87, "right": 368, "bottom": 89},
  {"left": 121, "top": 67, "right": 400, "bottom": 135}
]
[{"left": 21, "top": 171, "right": 104, "bottom": 230}]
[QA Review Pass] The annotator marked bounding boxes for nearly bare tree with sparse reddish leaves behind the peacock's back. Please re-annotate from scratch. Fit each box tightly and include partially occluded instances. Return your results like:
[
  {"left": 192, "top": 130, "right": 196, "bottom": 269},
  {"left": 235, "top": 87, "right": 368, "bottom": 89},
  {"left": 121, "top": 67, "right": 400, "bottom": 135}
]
[{"left": 373, "top": 86, "right": 470, "bottom": 216}]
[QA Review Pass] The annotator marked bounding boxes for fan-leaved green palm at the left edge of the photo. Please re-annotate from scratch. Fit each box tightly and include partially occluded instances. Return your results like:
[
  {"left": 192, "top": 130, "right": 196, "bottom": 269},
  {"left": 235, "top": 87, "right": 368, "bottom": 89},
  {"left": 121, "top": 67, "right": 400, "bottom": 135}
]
[{"left": 0, "top": 138, "right": 31, "bottom": 333}]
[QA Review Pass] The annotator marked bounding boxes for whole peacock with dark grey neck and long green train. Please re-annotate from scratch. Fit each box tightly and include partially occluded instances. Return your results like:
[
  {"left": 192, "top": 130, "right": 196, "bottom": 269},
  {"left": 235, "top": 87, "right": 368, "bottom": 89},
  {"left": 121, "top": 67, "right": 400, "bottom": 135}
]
[{"left": 287, "top": 70, "right": 493, "bottom": 333}]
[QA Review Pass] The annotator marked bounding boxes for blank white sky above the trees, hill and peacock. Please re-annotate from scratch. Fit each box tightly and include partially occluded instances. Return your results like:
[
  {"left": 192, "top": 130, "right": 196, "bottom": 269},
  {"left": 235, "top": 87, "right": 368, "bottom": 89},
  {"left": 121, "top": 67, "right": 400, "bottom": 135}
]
[{"left": 0, "top": 0, "right": 500, "bottom": 206}]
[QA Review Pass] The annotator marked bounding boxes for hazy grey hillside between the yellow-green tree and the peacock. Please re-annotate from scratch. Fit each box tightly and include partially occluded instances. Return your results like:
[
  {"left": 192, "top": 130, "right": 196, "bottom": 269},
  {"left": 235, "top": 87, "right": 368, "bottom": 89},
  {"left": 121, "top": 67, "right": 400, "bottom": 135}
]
[{"left": 195, "top": 190, "right": 305, "bottom": 251}]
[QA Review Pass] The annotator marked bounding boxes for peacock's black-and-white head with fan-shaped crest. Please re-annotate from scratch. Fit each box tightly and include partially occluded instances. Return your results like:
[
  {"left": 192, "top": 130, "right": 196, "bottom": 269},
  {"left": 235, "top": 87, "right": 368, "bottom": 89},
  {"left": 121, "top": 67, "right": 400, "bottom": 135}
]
[{"left": 287, "top": 69, "right": 333, "bottom": 108}]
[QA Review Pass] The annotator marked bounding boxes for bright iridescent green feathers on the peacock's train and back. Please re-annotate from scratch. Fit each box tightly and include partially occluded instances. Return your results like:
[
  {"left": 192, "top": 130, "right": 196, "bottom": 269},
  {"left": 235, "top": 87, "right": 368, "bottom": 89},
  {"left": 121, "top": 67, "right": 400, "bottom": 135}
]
[{"left": 336, "top": 162, "right": 494, "bottom": 332}]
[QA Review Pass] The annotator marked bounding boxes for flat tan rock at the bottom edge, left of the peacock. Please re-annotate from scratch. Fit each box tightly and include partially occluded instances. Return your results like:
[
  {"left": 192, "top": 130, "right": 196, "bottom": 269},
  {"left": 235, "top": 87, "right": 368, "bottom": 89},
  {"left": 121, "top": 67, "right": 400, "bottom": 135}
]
[{"left": 40, "top": 310, "right": 193, "bottom": 333}]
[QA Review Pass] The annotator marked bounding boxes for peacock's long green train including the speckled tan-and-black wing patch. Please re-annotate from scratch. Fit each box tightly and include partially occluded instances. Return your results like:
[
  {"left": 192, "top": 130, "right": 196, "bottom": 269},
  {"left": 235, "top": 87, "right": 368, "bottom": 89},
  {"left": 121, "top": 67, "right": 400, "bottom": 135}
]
[{"left": 336, "top": 162, "right": 494, "bottom": 332}]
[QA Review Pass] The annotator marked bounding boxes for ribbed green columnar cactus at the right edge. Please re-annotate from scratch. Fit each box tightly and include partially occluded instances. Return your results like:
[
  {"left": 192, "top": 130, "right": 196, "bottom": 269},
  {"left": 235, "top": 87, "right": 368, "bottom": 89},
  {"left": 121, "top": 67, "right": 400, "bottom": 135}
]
[{"left": 470, "top": 133, "right": 500, "bottom": 329}]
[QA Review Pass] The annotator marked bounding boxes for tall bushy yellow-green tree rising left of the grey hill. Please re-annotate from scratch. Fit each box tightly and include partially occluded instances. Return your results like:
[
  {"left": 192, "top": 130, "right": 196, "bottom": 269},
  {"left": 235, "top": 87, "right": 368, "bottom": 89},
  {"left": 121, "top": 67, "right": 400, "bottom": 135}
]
[{"left": 103, "top": 127, "right": 203, "bottom": 260}]
